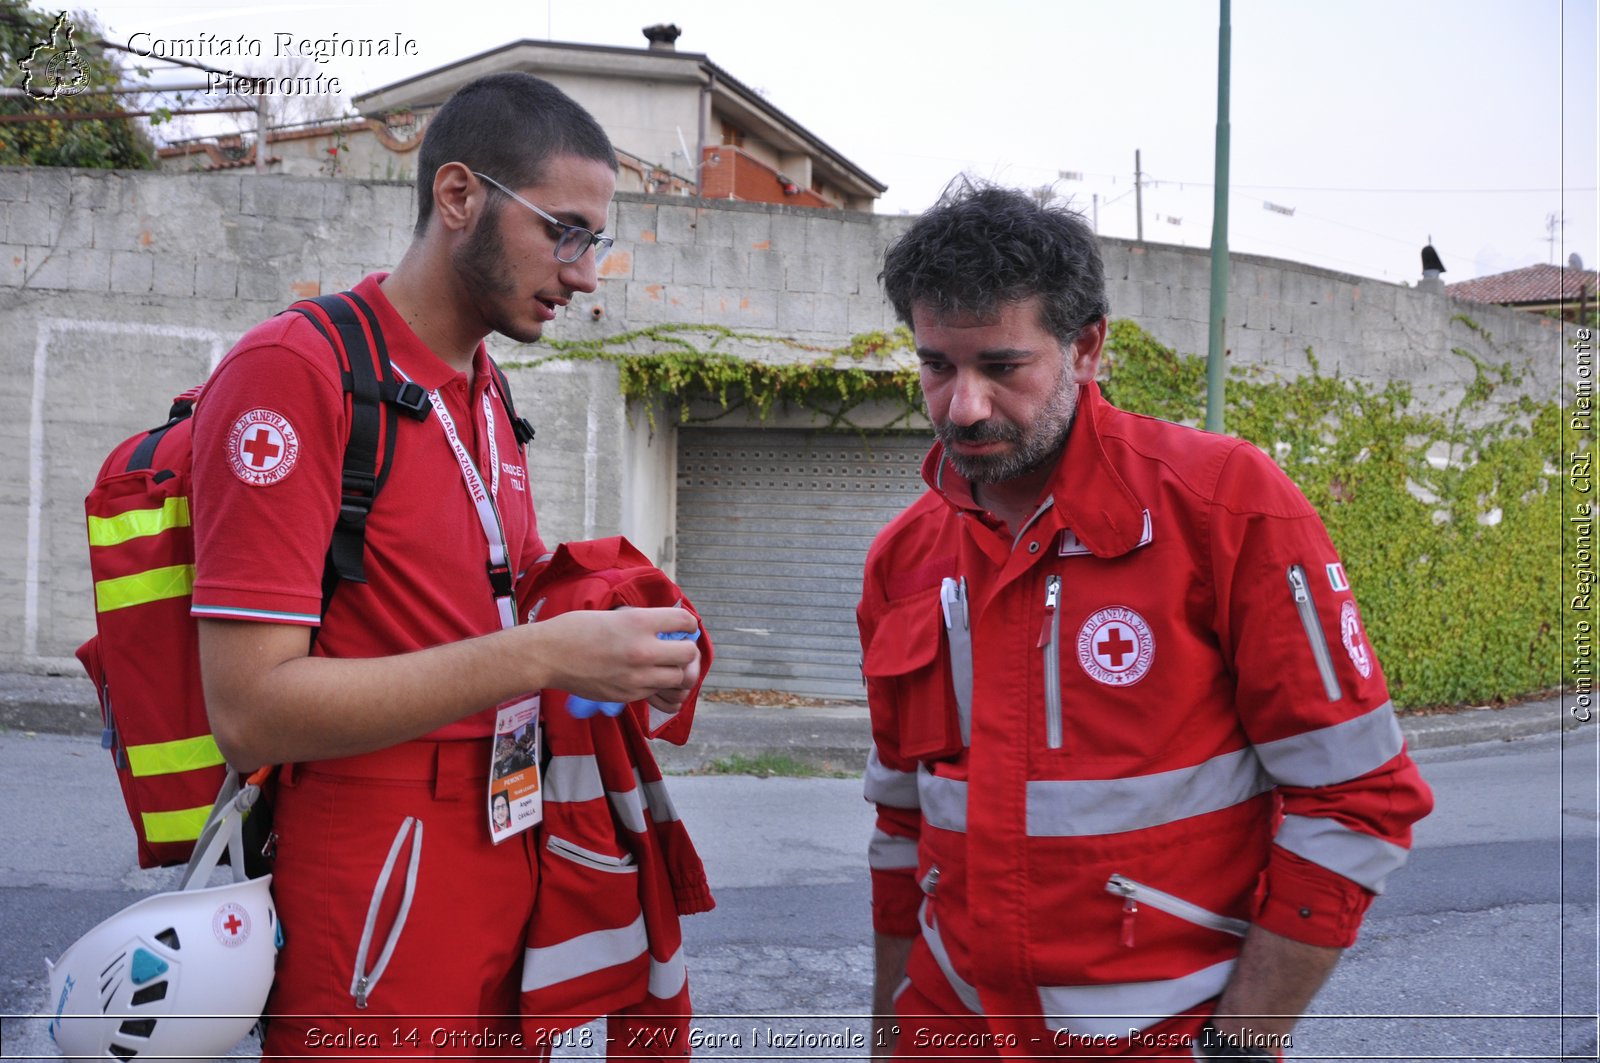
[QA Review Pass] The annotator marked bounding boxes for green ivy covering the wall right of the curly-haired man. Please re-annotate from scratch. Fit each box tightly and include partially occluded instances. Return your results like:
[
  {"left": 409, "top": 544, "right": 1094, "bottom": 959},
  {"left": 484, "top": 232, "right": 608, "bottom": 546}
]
[{"left": 1102, "top": 322, "right": 1561, "bottom": 706}]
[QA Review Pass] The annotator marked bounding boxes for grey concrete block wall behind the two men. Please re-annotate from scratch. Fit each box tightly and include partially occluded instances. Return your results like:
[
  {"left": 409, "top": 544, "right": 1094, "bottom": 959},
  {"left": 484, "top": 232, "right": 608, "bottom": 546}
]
[{"left": 0, "top": 168, "right": 1562, "bottom": 671}]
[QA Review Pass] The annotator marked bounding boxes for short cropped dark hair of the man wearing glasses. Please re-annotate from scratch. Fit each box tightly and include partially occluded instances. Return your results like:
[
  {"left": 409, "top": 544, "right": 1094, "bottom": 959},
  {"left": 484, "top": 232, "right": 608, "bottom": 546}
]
[{"left": 416, "top": 72, "right": 616, "bottom": 235}]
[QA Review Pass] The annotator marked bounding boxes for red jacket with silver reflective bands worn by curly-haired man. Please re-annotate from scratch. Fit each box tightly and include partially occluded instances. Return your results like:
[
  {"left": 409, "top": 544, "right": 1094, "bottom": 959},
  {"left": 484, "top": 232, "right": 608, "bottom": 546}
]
[{"left": 858, "top": 384, "right": 1432, "bottom": 1033}]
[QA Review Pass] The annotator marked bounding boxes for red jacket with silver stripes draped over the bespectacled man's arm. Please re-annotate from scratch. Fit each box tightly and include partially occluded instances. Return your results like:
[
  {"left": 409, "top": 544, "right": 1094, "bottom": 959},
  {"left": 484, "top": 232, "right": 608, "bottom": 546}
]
[{"left": 518, "top": 538, "right": 714, "bottom": 1055}]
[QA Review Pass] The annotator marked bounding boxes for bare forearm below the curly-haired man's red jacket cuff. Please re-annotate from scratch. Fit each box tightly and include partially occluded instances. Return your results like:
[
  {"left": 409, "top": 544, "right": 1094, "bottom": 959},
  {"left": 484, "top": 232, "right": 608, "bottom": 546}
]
[{"left": 1211, "top": 927, "right": 1344, "bottom": 1052}]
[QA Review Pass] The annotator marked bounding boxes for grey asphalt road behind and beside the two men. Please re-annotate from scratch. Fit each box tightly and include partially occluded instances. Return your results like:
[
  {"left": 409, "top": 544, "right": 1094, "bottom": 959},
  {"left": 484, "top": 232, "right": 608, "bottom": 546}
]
[{"left": 0, "top": 727, "right": 1600, "bottom": 1060}]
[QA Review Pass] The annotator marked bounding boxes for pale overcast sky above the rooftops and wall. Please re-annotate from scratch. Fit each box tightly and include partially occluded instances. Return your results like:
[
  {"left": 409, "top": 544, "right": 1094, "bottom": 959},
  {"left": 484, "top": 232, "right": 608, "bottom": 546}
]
[{"left": 43, "top": 0, "right": 1600, "bottom": 283}]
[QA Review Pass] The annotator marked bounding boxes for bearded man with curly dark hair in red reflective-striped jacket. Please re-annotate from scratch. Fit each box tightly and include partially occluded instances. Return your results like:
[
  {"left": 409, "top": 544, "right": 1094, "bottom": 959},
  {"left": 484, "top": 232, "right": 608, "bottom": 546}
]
[{"left": 858, "top": 184, "right": 1432, "bottom": 1060}]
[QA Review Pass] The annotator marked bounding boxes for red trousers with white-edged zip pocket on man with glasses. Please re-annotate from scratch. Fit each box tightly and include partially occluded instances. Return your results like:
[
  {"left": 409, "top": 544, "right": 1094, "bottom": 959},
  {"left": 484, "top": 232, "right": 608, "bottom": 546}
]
[{"left": 262, "top": 738, "right": 549, "bottom": 1058}]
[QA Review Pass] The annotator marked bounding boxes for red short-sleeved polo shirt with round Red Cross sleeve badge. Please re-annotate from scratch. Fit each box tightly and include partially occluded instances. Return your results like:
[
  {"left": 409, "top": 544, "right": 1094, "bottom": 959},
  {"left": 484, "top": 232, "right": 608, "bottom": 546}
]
[{"left": 192, "top": 274, "right": 544, "bottom": 738}]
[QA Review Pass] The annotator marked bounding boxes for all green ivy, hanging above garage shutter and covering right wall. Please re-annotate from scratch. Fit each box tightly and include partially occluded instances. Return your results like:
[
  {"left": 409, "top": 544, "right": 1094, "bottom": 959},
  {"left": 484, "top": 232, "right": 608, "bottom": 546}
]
[{"left": 512, "top": 320, "right": 1589, "bottom": 706}]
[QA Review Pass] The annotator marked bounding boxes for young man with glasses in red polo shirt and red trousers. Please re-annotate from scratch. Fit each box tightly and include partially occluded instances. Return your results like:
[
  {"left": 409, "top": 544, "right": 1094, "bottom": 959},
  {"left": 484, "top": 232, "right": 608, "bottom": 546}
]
[{"left": 194, "top": 74, "right": 701, "bottom": 1057}]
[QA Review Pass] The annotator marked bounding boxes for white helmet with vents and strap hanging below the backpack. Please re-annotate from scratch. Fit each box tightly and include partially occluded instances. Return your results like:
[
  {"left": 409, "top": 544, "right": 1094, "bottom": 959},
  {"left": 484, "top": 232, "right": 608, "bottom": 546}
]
[{"left": 50, "top": 768, "right": 282, "bottom": 1063}]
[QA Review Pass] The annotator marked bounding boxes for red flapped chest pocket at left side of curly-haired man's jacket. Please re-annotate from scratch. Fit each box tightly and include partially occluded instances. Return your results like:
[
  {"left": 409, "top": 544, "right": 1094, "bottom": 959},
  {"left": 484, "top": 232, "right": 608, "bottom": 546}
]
[{"left": 862, "top": 580, "right": 971, "bottom": 760}]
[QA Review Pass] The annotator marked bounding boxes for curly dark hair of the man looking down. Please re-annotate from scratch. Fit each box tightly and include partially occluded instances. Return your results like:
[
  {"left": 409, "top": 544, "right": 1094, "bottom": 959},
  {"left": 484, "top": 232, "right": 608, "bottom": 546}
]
[{"left": 878, "top": 176, "right": 1110, "bottom": 344}]
